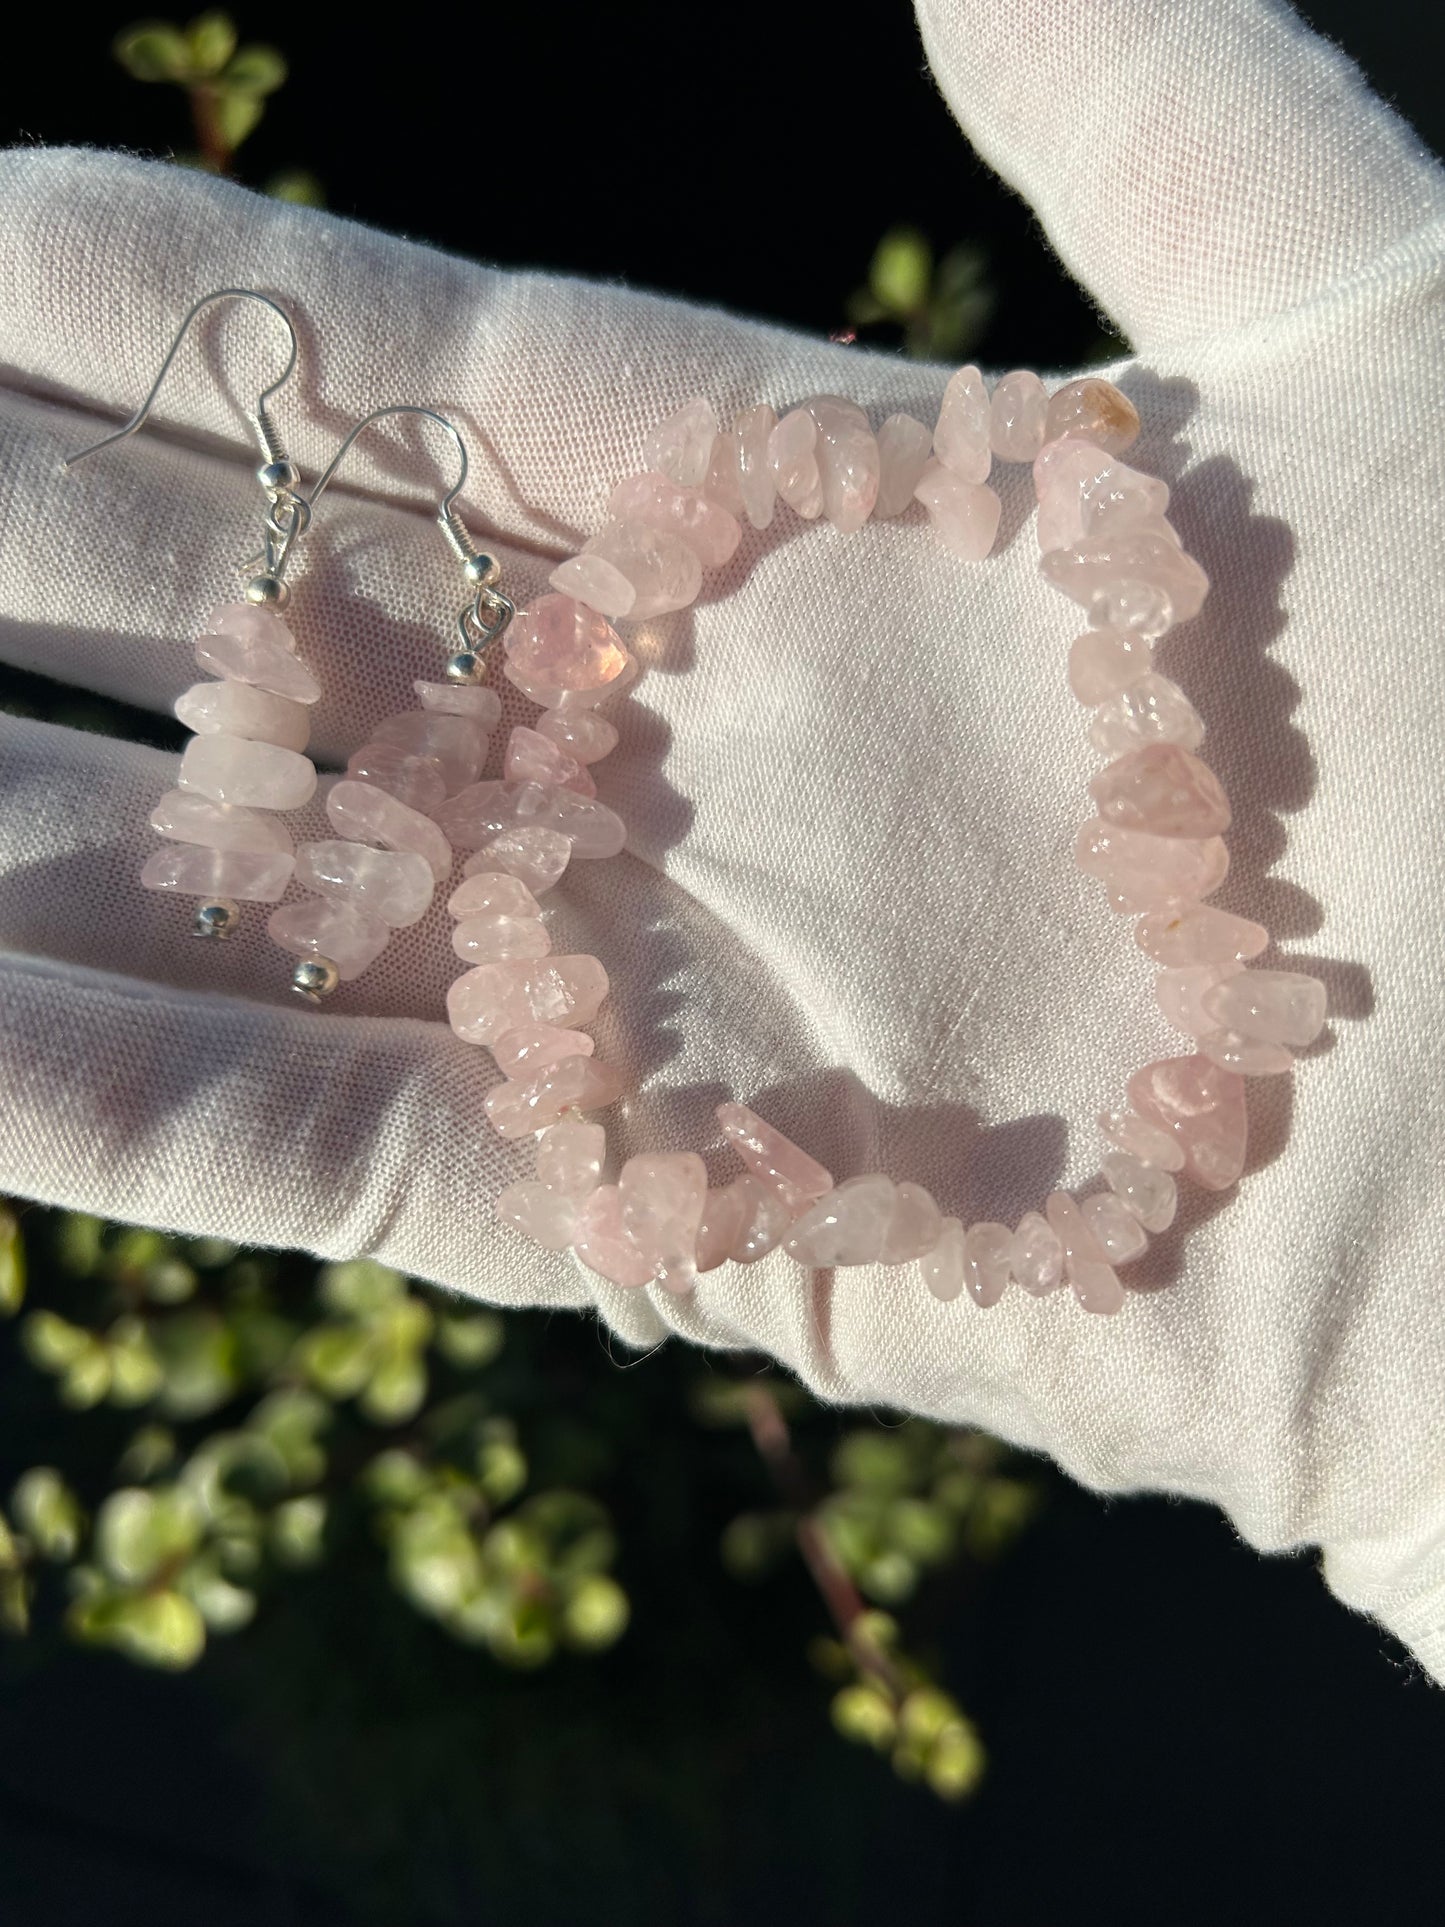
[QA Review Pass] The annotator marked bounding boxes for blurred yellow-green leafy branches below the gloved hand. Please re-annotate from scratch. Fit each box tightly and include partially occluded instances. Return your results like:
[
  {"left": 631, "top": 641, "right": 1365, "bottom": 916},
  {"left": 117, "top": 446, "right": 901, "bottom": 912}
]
[{"left": 0, "top": 1208, "right": 1037, "bottom": 1798}]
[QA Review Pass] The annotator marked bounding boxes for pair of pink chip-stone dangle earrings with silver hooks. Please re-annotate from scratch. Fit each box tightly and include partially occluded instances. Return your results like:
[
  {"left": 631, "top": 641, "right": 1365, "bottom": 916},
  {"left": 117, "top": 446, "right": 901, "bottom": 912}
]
[{"left": 64, "top": 289, "right": 512, "bottom": 1002}]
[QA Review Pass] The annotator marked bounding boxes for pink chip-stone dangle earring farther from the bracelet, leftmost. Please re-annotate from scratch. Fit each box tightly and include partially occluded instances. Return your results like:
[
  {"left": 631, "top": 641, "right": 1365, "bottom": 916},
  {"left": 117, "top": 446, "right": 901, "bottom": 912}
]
[{"left": 62, "top": 287, "right": 322, "bottom": 937}]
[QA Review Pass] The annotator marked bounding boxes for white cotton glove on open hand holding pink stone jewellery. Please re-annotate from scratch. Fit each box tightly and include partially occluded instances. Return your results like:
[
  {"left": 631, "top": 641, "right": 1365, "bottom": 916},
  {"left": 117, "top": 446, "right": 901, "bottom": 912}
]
[{"left": 0, "top": 0, "right": 1445, "bottom": 1675}]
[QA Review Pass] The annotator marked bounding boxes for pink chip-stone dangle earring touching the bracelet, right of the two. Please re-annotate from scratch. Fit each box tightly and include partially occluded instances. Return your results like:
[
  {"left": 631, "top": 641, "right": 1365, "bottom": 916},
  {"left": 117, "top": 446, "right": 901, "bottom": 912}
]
[{"left": 266, "top": 403, "right": 512, "bottom": 1004}]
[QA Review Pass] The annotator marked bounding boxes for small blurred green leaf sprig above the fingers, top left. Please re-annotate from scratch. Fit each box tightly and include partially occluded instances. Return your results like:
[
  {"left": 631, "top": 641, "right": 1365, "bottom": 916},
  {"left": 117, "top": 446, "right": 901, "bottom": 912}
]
[{"left": 114, "top": 13, "right": 324, "bottom": 206}]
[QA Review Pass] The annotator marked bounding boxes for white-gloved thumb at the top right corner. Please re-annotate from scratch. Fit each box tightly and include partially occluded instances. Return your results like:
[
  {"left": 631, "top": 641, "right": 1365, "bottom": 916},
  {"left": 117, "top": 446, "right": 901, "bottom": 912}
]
[{"left": 915, "top": 0, "right": 1445, "bottom": 351}]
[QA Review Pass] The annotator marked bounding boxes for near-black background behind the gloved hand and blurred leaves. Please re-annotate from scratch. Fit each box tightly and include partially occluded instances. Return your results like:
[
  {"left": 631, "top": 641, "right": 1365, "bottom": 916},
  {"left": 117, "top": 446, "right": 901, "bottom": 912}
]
[{"left": 0, "top": 0, "right": 1445, "bottom": 1927}]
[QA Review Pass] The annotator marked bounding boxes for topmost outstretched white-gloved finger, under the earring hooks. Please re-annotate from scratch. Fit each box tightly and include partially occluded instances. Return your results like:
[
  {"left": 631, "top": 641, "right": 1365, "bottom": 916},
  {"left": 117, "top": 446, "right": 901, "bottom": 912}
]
[{"left": 0, "top": 150, "right": 963, "bottom": 553}]
